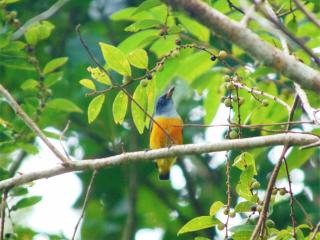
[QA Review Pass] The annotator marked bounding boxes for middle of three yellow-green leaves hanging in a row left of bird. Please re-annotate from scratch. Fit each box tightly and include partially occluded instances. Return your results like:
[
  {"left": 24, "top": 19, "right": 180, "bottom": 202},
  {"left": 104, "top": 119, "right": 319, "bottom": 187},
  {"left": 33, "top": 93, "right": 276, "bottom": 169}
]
[{"left": 112, "top": 91, "right": 128, "bottom": 124}]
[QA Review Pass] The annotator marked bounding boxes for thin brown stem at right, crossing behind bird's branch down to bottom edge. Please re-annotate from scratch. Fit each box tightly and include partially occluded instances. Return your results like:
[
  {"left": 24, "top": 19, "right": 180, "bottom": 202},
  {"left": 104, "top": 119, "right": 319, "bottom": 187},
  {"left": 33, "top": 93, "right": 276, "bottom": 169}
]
[{"left": 250, "top": 95, "right": 299, "bottom": 240}]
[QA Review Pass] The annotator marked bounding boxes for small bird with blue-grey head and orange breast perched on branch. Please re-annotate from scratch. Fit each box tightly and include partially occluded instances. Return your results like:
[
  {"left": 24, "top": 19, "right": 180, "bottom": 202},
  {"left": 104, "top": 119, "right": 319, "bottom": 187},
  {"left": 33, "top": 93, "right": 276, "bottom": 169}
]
[{"left": 150, "top": 87, "right": 183, "bottom": 180}]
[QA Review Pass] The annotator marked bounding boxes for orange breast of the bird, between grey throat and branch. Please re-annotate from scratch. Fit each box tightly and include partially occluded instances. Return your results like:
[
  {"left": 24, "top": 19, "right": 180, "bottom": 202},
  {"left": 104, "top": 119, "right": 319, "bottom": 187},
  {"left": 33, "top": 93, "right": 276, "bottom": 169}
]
[{"left": 150, "top": 117, "right": 183, "bottom": 149}]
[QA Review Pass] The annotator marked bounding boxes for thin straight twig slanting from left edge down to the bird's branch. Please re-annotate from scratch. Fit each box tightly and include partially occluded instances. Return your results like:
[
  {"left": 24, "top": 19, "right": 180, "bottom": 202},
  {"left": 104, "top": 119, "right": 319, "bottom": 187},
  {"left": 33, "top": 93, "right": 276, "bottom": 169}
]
[{"left": 0, "top": 84, "right": 69, "bottom": 164}]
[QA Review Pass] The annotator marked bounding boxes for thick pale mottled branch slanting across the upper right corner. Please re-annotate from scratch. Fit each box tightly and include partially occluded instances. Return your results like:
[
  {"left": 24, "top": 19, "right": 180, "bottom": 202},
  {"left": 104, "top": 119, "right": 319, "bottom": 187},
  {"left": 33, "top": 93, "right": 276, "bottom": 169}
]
[{"left": 167, "top": 0, "right": 320, "bottom": 91}]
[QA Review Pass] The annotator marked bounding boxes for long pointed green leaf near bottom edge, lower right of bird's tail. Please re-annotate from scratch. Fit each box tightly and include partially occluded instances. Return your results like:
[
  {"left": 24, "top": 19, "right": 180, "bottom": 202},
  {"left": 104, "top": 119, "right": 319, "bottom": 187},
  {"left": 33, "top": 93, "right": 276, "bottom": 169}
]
[{"left": 178, "top": 216, "right": 220, "bottom": 236}]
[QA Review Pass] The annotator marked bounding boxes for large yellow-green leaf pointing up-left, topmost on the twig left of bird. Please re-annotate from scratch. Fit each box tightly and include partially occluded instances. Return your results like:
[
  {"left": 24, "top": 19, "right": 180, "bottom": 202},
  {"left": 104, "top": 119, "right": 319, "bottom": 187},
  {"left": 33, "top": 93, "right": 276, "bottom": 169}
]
[{"left": 99, "top": 42, "right": 131, "bottom": 76}]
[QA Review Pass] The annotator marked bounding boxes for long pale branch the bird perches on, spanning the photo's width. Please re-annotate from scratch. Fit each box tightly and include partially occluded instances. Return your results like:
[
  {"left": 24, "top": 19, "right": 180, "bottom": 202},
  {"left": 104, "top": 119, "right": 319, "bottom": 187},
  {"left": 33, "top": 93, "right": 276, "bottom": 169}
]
[{"left": 0, "top": 133, "right": 319, "bottom": 190}]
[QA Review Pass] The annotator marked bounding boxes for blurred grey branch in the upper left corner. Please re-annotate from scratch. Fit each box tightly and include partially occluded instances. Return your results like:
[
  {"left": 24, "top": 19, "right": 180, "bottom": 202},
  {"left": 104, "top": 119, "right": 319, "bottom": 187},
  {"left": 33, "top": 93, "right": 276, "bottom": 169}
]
[{"left": 12, "top": 0, "right": 69, "bottom": 40}]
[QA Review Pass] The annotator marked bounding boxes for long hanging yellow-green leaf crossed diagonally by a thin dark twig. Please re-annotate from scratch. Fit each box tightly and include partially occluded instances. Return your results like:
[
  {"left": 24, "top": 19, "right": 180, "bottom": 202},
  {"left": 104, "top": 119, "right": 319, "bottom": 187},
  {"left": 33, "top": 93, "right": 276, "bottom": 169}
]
[{"left": 131, "top": 84, "right": 147, "bottom": 134}]
